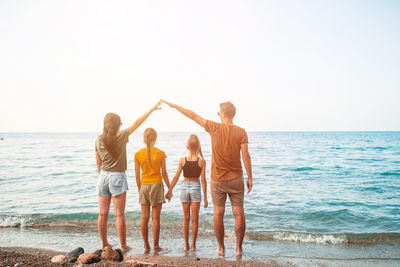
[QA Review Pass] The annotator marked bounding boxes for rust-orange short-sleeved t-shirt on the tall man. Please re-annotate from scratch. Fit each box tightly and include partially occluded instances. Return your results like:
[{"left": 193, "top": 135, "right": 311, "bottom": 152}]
[{"left": 205, "top": 120, "right": 249, "bottom": 181}]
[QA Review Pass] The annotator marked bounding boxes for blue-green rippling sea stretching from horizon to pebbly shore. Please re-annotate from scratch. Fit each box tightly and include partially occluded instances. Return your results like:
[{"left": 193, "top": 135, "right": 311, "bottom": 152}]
[{"left": 0, "top": 132, "right": 400, "bottom": 266}]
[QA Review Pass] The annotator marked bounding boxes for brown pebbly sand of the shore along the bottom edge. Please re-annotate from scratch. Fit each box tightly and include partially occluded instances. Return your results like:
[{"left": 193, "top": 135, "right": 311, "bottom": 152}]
[{"left": 0, "top": 247, "right": 280, "bottom": 267}]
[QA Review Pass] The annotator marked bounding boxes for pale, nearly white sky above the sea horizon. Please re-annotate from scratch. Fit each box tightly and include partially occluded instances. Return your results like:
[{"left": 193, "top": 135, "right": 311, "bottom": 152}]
[{"left": 0, "top": 0, "right": 400, "bottom": 132}]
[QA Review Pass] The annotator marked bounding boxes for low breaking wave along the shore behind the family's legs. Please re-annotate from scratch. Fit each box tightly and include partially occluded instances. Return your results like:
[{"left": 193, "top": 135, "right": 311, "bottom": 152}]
[{"left": 0, "top": 215, "right": 400, "bottom": 246}]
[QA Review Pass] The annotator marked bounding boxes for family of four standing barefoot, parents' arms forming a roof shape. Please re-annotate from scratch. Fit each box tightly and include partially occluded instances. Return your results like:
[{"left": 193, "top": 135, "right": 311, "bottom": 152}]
[{"left": 95, "top": 100, "right": 253, "bottom": 256}]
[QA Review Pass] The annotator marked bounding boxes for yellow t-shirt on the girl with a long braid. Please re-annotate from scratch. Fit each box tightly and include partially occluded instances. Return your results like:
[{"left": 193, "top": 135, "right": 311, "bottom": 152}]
[{"left": 135, "top": 147, "right": 167, "bottom": 185}]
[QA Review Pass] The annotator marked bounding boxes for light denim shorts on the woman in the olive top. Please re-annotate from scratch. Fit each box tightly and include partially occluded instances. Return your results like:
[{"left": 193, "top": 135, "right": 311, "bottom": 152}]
[{"left": 96, "top": 170, "right": 128, "bottom": 197}]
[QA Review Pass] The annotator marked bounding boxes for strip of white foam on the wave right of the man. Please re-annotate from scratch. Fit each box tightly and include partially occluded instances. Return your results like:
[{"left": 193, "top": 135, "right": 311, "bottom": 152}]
[{"left": 273, "top": 232, "right": 347, "bottom": 245}]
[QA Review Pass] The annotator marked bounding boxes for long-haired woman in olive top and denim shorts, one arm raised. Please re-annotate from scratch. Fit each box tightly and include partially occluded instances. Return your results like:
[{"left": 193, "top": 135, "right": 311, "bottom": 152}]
[{"left": 95, "top": 101, "right": 161, "bottom": 252}]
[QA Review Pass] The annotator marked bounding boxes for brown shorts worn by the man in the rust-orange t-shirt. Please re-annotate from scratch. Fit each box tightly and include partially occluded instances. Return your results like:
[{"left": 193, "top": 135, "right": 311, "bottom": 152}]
[{"left": 211, "top": 176, "right": 244, "bottom": 206}]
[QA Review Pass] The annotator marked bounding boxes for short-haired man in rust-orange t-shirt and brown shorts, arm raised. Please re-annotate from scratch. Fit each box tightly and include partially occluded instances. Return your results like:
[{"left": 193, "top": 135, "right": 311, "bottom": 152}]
[{"left": 164, "top": 101, "right": 253, "bottom": 256}]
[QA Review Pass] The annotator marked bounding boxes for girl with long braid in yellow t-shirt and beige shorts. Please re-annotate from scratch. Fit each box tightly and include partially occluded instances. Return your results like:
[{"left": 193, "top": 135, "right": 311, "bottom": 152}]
[{"left": 135, "top": 128, "right": 170, "bottom": 253}]
